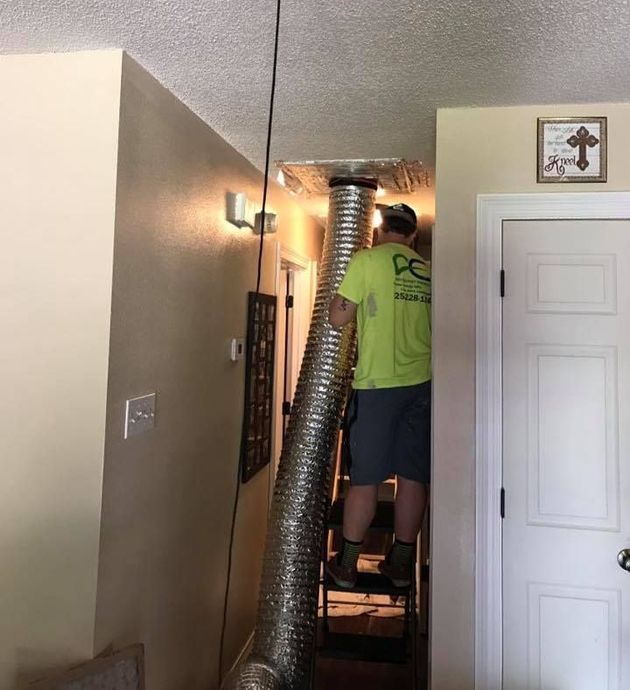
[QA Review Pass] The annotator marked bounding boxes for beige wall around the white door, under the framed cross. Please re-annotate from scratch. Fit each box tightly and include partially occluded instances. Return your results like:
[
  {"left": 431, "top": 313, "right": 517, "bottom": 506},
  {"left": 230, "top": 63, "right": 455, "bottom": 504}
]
[{"left": 431, "top": 103, "right": 630, "bottom": 690}]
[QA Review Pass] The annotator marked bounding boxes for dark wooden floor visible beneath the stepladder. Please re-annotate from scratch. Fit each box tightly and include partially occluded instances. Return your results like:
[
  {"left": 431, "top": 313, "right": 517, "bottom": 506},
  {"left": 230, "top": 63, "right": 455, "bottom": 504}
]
[{"left": 315, "top": 615, "right": 427, "bottom": 690}]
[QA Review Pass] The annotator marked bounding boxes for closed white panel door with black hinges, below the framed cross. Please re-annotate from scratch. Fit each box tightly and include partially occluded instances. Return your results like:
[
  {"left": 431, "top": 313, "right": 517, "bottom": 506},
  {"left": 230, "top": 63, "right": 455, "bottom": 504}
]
[{"left": 503, "top": 220, "right": 630, "bottom": 690}]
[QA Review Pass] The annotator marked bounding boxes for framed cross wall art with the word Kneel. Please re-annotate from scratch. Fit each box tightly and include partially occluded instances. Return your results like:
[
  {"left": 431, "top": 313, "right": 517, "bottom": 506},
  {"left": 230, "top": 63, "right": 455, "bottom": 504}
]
[{"left": 538, "top": 117, "right": 608, "bottom": 182}]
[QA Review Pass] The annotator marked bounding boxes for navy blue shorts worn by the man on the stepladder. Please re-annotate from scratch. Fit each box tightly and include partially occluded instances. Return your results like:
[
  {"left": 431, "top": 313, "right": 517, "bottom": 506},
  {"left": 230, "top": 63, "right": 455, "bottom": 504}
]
[{"left": 346, "top": 381, "right": 431, "bottom": 485}]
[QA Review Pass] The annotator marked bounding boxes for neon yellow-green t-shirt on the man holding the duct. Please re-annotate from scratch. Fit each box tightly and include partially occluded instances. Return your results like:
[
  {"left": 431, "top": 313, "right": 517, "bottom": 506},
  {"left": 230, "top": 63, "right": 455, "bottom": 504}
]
[{"left": 337, "top": 242, "right": 431, "bottom": 389}]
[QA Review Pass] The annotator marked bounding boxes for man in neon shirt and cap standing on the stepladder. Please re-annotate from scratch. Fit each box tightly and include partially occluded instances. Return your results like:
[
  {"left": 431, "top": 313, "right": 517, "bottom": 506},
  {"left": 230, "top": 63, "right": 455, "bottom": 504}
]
[{"left": 326, "top": 204, "right": 431, "bottom": 588}]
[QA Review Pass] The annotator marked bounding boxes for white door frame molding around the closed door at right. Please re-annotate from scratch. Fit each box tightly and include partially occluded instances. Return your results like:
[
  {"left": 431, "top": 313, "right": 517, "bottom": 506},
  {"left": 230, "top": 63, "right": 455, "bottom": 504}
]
[{"left": 475, "top": 192, "right": 630, "bottom": 690}]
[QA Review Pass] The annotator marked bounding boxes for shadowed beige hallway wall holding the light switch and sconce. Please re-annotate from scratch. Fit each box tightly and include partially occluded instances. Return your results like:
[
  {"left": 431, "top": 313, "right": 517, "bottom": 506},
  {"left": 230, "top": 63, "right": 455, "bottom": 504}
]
[{"left": 96, "top": 57, "right": 321, "bottom": 690}]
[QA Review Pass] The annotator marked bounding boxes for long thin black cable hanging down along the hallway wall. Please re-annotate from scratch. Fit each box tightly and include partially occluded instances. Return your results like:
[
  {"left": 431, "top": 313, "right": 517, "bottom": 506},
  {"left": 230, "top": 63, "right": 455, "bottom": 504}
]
[{"left": 218, "top": 0, "right": 281, "bottom": 689}]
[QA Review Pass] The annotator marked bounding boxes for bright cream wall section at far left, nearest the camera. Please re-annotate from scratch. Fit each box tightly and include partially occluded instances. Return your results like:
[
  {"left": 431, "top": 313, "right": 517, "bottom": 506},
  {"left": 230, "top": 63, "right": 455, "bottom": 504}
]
[{"left": 0, "top": 52, "right": 121, "bottom": 689}]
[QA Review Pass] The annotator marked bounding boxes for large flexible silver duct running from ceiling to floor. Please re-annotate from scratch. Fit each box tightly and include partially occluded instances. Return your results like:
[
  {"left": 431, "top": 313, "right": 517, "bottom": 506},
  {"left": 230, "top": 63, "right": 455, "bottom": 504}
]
[{"left": 232, "top": 180, "right": 376, "bottom": 690}]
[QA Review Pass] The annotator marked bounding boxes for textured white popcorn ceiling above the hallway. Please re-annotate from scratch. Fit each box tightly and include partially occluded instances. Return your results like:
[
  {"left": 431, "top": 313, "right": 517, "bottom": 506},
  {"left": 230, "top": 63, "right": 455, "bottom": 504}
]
[{"left": 0, "top": 0, "right": 630, "bottom": 177}]
